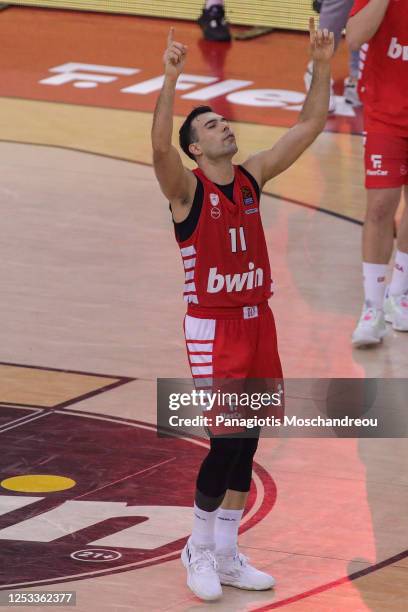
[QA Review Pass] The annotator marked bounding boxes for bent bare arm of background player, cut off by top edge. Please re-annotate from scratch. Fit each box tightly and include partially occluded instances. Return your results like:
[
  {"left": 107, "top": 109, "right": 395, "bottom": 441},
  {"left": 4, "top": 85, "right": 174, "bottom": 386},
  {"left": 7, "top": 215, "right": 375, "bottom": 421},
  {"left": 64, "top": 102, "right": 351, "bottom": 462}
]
[{"left": 346, "top": 0, "right": 389, "bottom": 51}]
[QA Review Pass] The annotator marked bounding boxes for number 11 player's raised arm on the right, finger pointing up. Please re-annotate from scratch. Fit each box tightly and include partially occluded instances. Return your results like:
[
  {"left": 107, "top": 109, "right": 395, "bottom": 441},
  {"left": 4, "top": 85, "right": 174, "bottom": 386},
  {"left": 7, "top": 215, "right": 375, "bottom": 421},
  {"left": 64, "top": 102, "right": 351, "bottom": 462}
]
[{"left": 243, "top": 18, "right": 334, "bottom": 188}]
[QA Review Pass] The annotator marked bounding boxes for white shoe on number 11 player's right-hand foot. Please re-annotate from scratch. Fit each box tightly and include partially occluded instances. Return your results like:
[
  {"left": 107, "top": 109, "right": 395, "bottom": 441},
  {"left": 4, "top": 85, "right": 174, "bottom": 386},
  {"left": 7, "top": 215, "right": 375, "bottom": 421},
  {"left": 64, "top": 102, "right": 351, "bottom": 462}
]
[{"left": 216, "top": 550, "right": 275, "bottom": 591}]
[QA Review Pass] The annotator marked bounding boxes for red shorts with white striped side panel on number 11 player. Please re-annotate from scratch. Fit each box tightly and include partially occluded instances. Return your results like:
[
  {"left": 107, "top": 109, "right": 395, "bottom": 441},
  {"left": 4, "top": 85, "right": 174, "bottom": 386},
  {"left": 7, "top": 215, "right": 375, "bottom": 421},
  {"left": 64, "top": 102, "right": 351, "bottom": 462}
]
[{"left": 184, "top": 302, "right": 283, "bottom": 434}]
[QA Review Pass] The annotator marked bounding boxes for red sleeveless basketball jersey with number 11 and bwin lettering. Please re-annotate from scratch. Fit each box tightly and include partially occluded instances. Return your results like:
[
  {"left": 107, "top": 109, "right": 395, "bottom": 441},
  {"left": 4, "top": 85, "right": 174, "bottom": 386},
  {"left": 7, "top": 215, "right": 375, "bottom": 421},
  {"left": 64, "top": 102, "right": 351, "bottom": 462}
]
[{"left": 179, "top": 166, "right": 272, "bottom": 308}]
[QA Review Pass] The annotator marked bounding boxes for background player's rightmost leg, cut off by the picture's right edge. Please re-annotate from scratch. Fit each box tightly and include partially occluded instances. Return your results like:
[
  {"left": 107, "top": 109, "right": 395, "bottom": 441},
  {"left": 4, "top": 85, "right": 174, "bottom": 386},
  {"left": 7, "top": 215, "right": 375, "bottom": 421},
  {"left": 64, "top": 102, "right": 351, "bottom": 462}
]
[{"left": 384, "top": 183, "right": 408, "bottom": 331}]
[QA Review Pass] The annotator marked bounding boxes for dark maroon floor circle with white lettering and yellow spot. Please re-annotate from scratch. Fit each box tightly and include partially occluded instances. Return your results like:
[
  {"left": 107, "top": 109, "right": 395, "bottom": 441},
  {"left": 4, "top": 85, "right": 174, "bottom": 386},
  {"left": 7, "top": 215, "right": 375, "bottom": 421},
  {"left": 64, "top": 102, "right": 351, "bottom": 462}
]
[{"left": 0, "top": 411, "right": 276, "bottom": 590}]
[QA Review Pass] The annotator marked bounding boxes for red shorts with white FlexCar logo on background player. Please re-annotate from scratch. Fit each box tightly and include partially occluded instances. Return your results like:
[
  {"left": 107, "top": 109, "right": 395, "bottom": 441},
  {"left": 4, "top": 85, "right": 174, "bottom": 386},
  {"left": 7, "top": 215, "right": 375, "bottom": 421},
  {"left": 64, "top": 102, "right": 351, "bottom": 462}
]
[{"left": 364, "top": 129, "right": 408, "bottom": 189}]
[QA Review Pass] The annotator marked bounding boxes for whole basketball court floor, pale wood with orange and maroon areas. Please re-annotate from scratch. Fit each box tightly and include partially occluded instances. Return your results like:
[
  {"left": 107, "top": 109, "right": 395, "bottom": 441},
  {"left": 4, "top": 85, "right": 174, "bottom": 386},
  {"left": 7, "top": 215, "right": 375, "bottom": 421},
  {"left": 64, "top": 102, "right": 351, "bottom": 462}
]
[{"left": 0, "top": 7, "right": 408, "bottom": 612}]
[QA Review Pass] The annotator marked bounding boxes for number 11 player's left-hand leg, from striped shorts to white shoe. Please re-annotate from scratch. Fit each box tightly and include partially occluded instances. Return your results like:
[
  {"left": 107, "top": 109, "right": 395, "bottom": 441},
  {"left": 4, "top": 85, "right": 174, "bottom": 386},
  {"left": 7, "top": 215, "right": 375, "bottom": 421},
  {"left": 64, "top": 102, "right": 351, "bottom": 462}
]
[{"left": 182, "top": 315, "right": 250, "bottom": 600}]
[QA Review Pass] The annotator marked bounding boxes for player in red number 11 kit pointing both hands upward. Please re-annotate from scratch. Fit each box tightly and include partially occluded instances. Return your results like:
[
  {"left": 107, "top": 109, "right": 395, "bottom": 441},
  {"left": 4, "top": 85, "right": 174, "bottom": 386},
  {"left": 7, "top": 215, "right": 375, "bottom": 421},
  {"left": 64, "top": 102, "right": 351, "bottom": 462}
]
[{"left": 152, "top": 19, "right": 334, "bottom": 600}]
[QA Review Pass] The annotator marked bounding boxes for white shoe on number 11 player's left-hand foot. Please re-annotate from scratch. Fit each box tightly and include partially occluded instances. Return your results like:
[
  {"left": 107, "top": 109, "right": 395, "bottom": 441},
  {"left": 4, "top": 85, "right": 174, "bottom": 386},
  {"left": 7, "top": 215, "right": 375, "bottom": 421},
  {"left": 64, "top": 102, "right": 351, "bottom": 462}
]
[{"left": 181, "top": 538, "right": 222, "bottom": 601}]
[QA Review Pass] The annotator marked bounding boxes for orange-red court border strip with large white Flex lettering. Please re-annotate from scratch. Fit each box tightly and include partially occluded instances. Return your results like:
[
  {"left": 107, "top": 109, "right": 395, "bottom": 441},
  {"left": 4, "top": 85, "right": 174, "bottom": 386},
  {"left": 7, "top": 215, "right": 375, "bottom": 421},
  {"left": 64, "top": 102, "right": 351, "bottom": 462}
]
[{"left": 0, "top": 7, "right": 362, "bottom": 133}]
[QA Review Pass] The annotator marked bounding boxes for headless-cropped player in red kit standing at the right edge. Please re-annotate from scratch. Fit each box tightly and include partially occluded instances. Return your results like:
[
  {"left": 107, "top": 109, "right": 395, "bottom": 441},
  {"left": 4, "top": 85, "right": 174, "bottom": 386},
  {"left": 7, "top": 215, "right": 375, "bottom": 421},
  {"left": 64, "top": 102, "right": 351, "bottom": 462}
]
[{"left": 347, "top": 0, "right": 408, "bottom": 347}]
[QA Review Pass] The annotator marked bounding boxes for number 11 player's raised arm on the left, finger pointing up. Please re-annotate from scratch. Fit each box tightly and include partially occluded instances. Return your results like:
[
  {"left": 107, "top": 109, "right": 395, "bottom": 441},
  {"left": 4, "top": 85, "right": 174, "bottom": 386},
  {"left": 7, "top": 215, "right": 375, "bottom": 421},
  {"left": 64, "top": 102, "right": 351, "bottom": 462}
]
[{"left": 152, "top": 28, "right": 196, "bottom": 221}]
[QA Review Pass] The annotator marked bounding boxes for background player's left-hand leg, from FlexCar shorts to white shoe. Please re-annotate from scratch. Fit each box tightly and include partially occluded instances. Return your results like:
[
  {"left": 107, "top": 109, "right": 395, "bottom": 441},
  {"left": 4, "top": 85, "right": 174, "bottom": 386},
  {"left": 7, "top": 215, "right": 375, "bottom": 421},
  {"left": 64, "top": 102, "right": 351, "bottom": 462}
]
[{"left": 352, "top": 133, "right": 403, "bottom": 348}]
